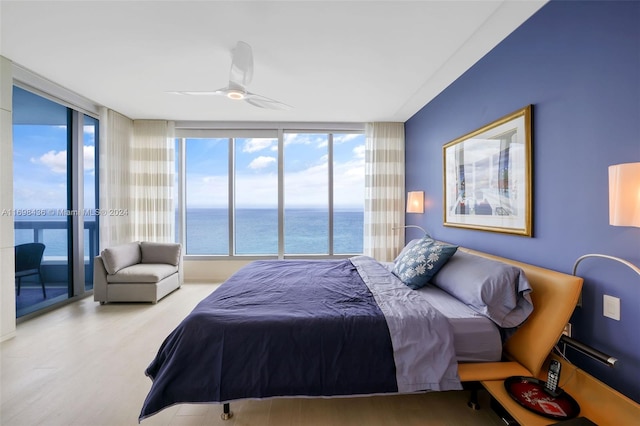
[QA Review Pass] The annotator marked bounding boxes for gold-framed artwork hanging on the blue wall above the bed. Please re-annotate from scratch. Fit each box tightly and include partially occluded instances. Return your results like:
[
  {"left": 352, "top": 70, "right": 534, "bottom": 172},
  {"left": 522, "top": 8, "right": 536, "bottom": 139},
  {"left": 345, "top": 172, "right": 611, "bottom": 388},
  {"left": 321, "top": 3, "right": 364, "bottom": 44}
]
[{"left": 442, "top": 105, "right": 532, "bottom": 237}]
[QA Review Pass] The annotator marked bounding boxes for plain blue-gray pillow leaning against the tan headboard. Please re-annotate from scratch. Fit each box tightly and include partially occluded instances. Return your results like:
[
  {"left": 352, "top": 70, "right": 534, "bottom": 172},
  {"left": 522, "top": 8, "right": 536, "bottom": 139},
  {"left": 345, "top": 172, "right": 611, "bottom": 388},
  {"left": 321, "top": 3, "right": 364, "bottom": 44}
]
[{"left": 431, "top": 251, "right": 533, "bottom": 328}]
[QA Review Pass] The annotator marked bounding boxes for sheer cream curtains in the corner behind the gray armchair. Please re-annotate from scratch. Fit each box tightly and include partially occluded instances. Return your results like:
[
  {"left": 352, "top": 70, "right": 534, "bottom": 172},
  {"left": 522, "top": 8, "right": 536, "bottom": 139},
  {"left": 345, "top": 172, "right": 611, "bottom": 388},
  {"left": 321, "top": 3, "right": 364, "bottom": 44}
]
[{"left": 99, "top": 108, "right": 175, "bottom": 249}]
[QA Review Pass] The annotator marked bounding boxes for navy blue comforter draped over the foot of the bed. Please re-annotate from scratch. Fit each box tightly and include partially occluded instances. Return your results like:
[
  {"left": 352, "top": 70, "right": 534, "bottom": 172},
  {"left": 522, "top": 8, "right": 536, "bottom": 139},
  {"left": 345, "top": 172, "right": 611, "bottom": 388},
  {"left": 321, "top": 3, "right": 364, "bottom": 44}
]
[{"left": 140, "top": 260, "right": 398, "bottom": 419}]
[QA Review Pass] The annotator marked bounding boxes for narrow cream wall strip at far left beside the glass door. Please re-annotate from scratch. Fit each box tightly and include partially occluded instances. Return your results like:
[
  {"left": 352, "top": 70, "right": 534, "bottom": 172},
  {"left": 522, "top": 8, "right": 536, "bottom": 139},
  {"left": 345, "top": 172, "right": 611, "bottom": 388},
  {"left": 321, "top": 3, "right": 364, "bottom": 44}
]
[{"left": 0, "top": 56, "right": 16, "bottom": 341}]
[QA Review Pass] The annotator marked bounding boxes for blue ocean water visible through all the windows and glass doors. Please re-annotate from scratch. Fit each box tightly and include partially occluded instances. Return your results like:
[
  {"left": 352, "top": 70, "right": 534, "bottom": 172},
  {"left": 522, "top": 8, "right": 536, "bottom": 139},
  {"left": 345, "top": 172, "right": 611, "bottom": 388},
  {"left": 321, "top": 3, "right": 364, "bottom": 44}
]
[{"left": 15, "top": 209, "right": 364, "bottom": 256}]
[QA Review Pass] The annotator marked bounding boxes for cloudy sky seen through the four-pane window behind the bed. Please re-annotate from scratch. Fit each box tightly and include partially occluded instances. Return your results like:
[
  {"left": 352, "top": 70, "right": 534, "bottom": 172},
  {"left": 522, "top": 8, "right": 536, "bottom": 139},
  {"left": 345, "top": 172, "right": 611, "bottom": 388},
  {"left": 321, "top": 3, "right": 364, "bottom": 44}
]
[{"left": 186, "top": 133, "right": 364, "bottom": 209}]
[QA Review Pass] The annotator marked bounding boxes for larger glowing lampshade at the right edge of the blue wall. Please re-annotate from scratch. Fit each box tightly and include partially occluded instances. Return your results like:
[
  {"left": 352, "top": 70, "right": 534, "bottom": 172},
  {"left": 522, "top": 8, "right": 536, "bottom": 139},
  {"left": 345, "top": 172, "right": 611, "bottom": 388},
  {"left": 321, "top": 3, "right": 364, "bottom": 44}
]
[{"left": 609, "top": 163, "right": 640, "bottom": 228}]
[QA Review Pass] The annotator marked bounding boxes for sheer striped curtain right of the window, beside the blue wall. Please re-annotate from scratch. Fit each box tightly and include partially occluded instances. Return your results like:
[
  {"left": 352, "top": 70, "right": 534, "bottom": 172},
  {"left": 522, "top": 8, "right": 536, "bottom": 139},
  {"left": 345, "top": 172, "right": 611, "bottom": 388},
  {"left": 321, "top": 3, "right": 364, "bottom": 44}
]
[{"left": 364, "top": 123, "right": 405, "bottom": 262}]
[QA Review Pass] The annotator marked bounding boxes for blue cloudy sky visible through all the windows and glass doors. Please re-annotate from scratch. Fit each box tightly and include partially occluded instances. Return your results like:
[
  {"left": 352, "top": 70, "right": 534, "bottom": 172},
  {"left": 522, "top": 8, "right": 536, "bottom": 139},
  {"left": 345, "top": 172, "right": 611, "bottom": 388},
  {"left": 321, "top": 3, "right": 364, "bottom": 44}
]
[{"left": 13, "top": 125, "right": 364, "bottom": 213}]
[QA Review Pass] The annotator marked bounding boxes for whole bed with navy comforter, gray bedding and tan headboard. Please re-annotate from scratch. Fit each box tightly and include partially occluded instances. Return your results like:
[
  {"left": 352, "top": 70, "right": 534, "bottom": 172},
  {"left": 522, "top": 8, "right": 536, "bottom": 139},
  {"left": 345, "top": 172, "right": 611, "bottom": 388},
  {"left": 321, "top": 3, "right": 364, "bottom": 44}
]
[{"left": 139, "top": 241, "right": 581, "bottom": 420}]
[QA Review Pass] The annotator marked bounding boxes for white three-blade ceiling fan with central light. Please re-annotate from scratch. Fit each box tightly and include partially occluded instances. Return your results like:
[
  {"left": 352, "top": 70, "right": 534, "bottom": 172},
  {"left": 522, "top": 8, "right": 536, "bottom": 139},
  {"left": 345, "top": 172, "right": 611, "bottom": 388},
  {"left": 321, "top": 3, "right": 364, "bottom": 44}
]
[{"left": 171, "top": 41, "right": 292, "bottom": 110}]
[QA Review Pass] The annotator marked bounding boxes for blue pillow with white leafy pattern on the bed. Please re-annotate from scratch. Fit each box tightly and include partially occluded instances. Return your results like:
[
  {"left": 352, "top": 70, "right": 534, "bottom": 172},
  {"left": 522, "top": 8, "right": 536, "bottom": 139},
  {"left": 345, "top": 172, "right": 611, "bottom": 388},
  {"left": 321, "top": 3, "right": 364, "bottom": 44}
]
[{"left": 393, "top": 237, "right": 458, "bottom": 290}]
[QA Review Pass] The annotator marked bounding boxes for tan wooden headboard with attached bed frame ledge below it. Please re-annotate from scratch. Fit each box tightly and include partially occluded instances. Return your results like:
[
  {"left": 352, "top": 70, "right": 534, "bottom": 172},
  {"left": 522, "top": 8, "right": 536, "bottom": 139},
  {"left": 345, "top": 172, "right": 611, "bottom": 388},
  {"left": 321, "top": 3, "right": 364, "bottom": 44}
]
[{"left": 458, "top": 247, "right": 583, "bottom": 382}]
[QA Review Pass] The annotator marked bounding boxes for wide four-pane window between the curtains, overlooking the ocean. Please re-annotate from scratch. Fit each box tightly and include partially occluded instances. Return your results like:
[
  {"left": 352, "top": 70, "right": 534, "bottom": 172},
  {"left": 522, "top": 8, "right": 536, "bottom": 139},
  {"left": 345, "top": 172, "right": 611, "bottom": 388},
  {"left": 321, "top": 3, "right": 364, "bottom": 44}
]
[{"left": 176, "top": 125, "right": 364, "bottom": 257}]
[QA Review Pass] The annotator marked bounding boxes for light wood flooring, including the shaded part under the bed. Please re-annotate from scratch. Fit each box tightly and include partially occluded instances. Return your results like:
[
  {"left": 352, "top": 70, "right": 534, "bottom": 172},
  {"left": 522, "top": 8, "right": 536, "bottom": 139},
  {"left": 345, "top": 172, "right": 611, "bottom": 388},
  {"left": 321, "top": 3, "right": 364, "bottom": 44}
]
[{"left": 0, "top": 284, "right": 503, "bottom": 426}]
